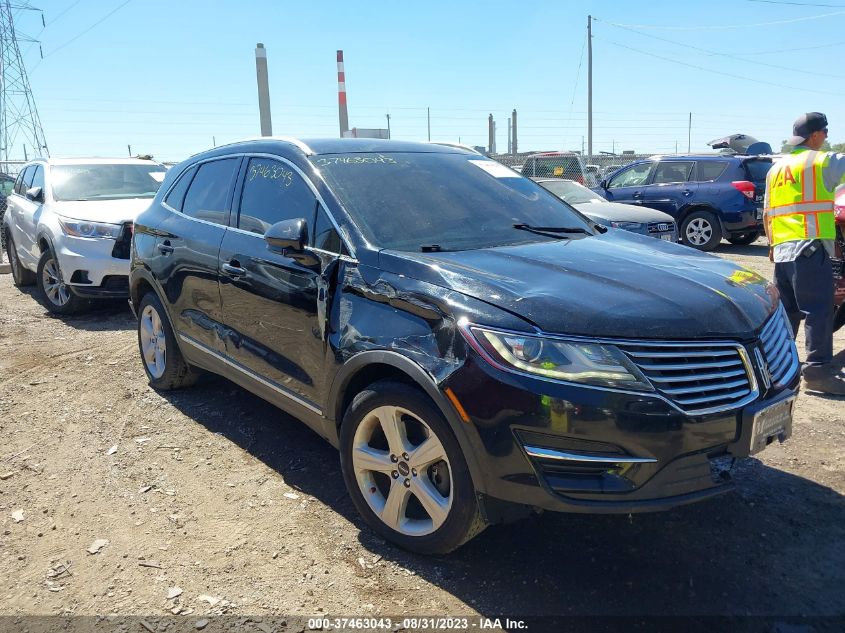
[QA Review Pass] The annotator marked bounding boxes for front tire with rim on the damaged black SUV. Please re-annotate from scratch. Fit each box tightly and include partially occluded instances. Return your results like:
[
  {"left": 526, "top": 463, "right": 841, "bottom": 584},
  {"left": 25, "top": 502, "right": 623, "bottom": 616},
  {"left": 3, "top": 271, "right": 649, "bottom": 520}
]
[{"left": 340, "top": 381, "right": 486, "bottom": 554}]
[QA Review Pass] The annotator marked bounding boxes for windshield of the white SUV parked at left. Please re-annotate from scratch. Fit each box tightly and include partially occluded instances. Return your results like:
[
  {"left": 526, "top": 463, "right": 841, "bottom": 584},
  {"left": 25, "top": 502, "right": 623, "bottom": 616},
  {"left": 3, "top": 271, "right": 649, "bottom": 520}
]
[{"left": 50, "top": 163, "right": 165, "bottom": 201}]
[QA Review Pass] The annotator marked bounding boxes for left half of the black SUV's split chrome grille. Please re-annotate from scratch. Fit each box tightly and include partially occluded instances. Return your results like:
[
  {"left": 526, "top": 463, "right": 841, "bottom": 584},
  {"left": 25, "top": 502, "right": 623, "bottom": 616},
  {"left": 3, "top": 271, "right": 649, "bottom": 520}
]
[{"left": 619, "top": 343, "right": 757, "bottom": 414}]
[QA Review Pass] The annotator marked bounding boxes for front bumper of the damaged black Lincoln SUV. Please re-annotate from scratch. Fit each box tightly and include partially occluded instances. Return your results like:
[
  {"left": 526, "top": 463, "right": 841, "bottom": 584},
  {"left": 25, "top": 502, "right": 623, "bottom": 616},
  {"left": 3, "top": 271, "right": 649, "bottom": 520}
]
[{"left": 444, "top": 359, "right": 800, "bottom": 513}]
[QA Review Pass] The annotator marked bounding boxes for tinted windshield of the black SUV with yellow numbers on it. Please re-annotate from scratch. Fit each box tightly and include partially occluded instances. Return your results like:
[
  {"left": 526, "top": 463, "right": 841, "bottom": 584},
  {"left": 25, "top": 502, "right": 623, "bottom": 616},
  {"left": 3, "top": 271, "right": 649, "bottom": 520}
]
[{"left": 311, "top": 152, "right": 593, "bottom": 251}]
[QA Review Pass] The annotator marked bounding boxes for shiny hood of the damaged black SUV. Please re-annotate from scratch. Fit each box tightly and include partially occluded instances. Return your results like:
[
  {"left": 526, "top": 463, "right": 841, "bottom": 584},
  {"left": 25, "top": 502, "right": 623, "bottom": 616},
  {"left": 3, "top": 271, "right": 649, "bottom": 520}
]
[{"left": 379, "top": 231, "right": 778, "bottom": 339}]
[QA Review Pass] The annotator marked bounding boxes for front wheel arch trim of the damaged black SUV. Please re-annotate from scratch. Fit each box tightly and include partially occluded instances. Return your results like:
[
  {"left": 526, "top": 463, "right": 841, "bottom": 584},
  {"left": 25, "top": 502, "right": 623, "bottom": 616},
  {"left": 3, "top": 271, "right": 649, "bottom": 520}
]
[{"left": 325, "top": 350, "right": 486, "bottom": 493}]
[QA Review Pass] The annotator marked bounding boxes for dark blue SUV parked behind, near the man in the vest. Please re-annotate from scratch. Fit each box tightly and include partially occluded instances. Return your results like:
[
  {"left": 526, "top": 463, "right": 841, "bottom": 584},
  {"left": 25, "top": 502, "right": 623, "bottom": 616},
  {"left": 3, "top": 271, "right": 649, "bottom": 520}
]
[{"left": 593, "top": 154, "right": 772, "bottom": 251}]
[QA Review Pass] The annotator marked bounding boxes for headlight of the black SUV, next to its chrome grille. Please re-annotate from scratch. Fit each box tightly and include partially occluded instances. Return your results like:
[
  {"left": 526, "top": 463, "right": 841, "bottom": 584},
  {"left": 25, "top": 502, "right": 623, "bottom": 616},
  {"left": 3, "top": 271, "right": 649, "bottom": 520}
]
[{"left": 462, "top": 326, "right": 654, "bottom": 391}]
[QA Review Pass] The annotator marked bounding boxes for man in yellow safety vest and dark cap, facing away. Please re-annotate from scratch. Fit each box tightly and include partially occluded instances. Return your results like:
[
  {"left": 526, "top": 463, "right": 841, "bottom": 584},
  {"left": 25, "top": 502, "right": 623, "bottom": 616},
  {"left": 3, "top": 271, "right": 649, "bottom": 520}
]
[{"left": 764, "top": 112, "right": 845, "bottom": 395}]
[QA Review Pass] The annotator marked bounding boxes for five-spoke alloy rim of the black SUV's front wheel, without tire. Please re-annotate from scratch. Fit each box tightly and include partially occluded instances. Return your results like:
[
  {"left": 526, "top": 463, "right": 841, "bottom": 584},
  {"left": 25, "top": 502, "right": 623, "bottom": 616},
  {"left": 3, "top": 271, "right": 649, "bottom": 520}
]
[{"left": 352, "top": 406, "right": 453, "bottom": 536}]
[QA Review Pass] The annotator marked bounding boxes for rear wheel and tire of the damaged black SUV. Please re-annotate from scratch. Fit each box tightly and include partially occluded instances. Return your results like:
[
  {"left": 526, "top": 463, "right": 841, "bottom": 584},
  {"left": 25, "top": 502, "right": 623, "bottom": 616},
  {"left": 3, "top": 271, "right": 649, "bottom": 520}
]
[{"left": 138, "top": 292, "right": 199, "bottom": 391}]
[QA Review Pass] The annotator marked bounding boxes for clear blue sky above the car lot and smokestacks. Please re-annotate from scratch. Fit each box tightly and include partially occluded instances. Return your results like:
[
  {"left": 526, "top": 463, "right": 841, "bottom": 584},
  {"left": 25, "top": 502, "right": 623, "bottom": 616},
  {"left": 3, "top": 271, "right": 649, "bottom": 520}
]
[{"left": 13, "top": 0, "right": 845, "bottom": 160}]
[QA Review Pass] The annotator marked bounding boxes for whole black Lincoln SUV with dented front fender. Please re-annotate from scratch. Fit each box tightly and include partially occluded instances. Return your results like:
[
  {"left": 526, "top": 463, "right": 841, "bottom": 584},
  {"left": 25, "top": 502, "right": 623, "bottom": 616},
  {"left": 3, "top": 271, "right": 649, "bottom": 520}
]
[{"left": 131, "top": 138, "right": 799, "bottom": 553}]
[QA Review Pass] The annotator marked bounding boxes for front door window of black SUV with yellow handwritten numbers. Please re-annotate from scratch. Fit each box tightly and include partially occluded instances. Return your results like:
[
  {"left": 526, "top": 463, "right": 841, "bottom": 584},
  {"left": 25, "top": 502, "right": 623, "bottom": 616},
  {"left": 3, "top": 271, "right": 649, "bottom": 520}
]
[{"left": 238, "top": 157, "right": 317, "bottom": 235}]
